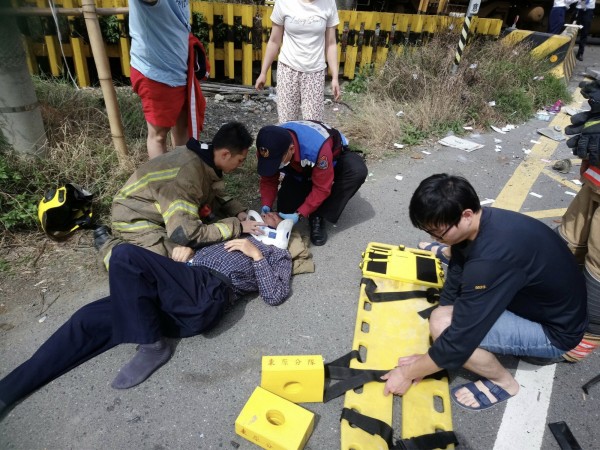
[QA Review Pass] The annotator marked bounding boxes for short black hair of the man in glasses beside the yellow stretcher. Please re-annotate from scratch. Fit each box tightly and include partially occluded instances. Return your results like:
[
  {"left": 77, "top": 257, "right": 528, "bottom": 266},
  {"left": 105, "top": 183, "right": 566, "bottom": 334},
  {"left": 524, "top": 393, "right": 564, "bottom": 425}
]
[{"left": 408, "top": 173, "right": 481, "bottom": 230}]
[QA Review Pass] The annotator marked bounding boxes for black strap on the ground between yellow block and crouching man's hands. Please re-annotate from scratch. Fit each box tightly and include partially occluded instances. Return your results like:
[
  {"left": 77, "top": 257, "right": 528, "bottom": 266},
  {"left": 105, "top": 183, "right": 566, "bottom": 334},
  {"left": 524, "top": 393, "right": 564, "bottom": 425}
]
[{"left": 323, "top": 350, "right": 391, "bottom": 403}]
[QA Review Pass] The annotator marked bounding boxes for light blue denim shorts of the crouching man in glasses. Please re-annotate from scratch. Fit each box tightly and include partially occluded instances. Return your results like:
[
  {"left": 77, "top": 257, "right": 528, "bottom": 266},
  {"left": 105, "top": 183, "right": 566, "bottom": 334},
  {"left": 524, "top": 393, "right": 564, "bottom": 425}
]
[{"left": 479, "top": 311, "right": 565, "bottom": 358}]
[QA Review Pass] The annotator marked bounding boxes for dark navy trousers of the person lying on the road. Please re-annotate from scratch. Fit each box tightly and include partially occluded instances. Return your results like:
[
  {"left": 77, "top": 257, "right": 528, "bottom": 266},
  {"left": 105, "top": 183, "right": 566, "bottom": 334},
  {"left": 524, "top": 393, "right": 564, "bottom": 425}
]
[{"left": 0, "top": 244, "right": 229, "bottom": 405}]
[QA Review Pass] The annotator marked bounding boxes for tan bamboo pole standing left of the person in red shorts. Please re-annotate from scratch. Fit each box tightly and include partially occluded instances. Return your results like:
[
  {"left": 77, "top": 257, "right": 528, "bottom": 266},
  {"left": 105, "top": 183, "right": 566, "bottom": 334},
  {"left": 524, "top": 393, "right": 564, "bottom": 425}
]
[{"left": 81, "top": 0, "right": 128, "bottom": 163}]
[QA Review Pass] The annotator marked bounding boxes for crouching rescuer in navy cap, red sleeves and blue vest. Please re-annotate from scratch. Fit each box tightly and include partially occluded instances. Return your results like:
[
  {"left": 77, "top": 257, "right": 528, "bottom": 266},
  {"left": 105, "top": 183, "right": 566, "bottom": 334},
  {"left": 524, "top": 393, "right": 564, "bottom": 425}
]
[{"left": 256, "top": 120, "right": 367, "bottom": 245}]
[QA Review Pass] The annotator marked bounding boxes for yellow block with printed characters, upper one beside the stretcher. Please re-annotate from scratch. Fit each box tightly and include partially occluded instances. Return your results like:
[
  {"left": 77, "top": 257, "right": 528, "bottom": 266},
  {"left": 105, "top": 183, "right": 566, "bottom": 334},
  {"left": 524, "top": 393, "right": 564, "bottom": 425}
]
[{"left": 260, "top": 355, "right": 325, "bottom": 403}]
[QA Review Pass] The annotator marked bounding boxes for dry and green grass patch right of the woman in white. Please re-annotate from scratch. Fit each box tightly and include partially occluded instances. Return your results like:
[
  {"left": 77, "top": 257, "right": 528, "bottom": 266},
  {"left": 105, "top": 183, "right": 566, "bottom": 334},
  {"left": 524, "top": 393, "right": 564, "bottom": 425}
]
[{"left": 342, "top": 33, "right": 571, "bottom": 156}]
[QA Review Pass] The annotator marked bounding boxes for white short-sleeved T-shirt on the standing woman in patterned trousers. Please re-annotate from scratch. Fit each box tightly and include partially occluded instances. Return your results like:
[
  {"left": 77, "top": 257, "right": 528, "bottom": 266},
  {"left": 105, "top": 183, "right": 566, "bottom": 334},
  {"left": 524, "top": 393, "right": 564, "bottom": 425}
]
[{"left": 271, "top": 0, "right": 340, "bottom": 72}]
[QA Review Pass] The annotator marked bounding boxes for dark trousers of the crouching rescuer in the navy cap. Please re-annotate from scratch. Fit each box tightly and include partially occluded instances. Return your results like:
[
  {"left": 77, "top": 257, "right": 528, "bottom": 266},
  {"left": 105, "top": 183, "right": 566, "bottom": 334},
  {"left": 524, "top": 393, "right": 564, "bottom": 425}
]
[{"left": 277, "top": 151, "right": 367, "bottom": 223}]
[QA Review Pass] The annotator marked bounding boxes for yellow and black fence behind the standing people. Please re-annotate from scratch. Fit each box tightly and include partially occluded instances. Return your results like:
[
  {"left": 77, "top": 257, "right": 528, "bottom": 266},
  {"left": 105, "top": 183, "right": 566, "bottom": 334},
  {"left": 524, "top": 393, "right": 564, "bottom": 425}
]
[{"left": 9, "top": 0, "right": 502, "bottom": 87}]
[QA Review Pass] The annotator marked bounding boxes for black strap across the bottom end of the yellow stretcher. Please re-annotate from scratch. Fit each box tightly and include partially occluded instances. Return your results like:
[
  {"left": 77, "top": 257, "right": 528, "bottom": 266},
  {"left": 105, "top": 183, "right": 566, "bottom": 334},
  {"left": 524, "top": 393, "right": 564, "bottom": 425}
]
[{"left": 340, "top": 408, "right": 458, "bottom": 450}]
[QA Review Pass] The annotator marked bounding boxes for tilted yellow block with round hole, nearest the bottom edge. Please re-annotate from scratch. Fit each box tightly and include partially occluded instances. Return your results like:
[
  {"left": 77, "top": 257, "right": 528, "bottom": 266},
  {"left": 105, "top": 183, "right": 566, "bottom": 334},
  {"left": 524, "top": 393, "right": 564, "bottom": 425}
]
[{"left": 235, "top": 387, "right": 315, "bottom": 450}]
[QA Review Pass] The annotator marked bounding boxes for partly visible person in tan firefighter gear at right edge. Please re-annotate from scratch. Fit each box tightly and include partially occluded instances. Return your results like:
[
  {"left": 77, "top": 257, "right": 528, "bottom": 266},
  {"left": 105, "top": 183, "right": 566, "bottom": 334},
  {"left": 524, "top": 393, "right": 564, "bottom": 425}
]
[{"left": 557, "top": 81, "right": 600, "bottom": 361}]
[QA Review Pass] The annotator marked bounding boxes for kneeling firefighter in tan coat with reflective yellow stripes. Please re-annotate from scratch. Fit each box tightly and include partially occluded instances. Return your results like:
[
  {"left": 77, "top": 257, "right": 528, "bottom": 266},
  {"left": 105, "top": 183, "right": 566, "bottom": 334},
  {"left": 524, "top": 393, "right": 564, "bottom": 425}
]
[{"left": 94, "top": 122, "right": 260, "bottom": 268}]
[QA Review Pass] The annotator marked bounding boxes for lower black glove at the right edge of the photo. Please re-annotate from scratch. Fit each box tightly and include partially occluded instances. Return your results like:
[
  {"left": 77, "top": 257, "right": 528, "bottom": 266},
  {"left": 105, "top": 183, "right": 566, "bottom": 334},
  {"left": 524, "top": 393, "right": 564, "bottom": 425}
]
[{"left": 565, "top": 112, "right": 600, "bottom": 166}]
